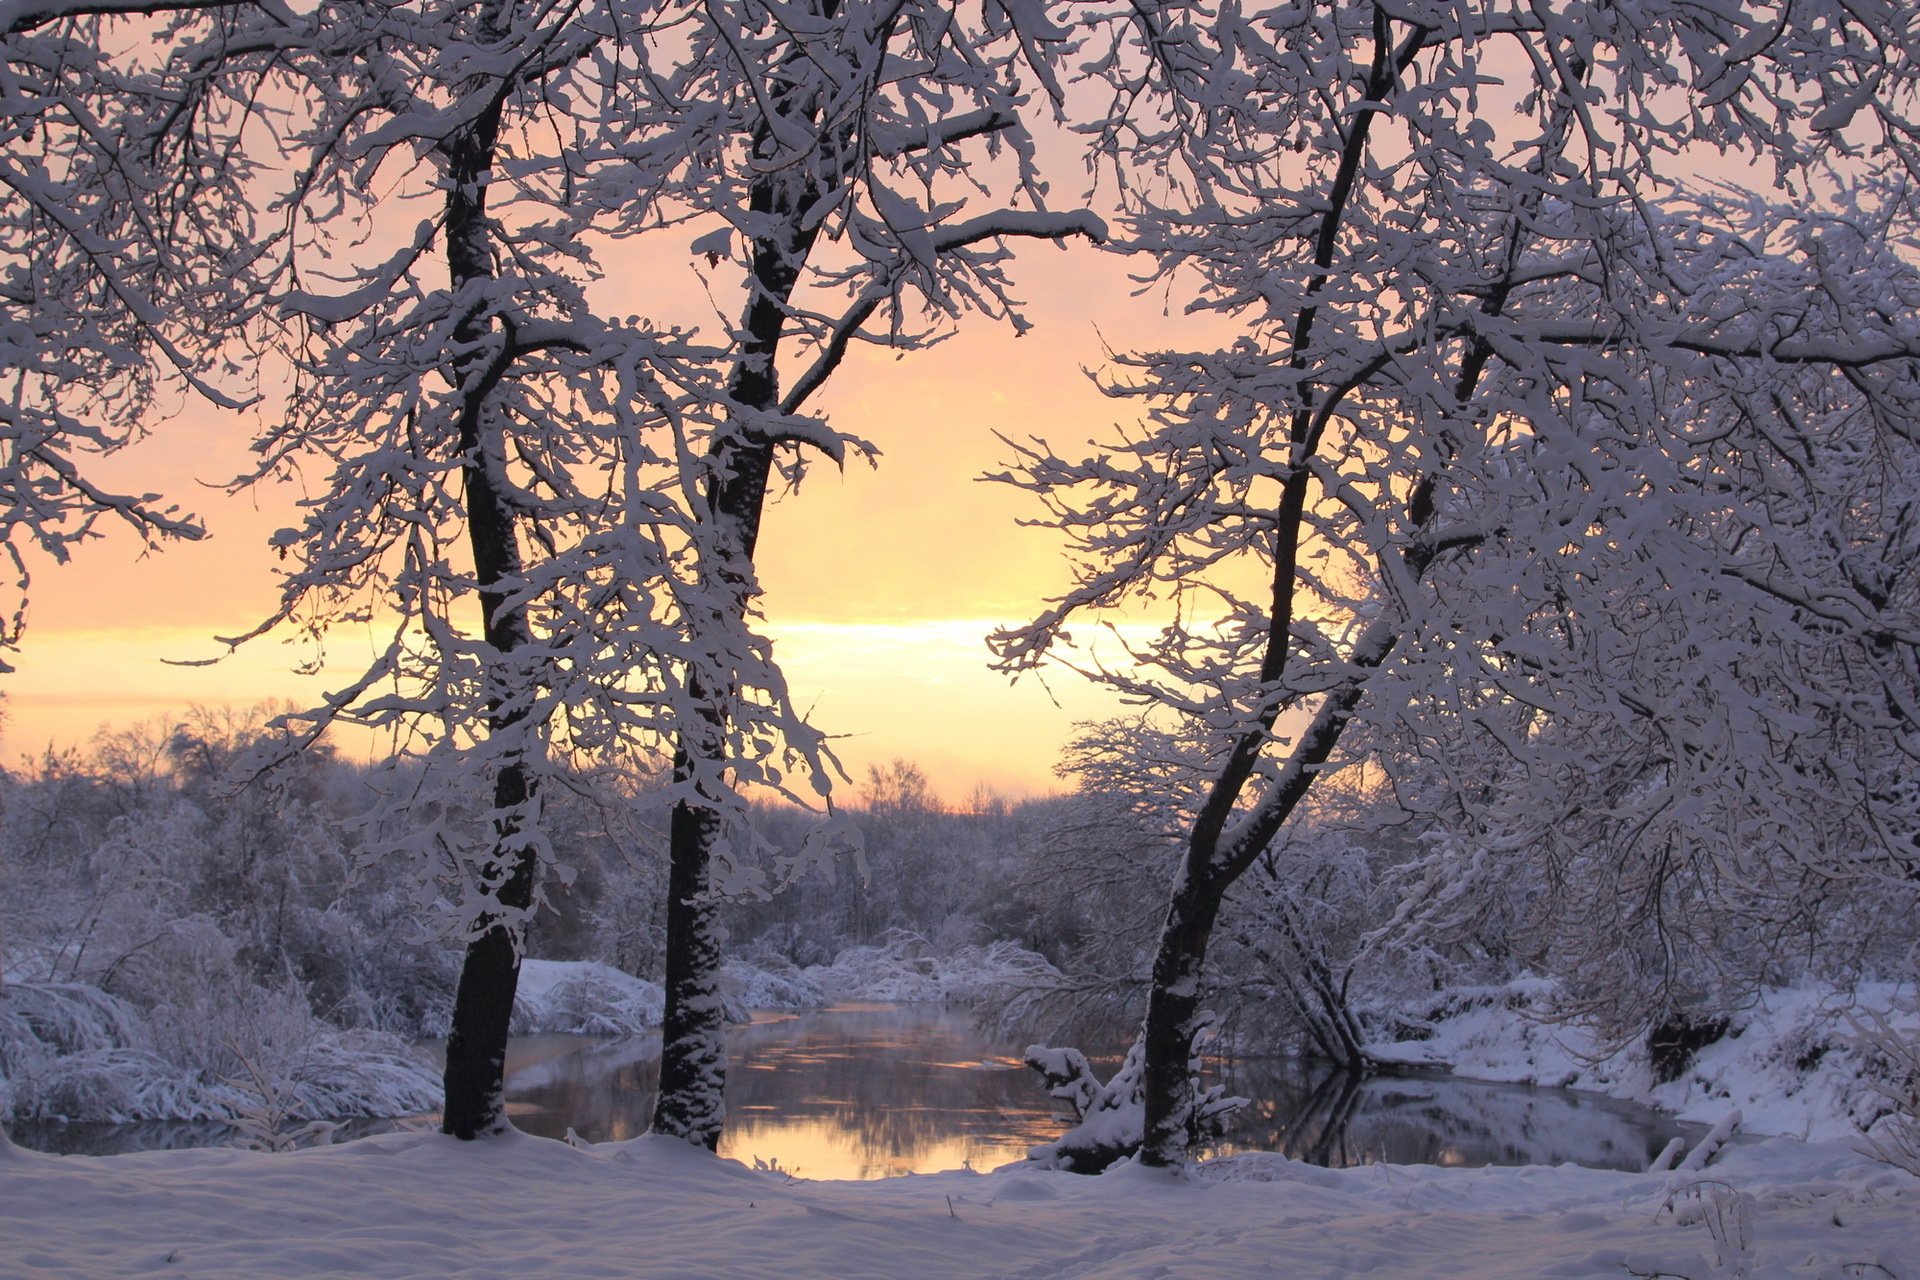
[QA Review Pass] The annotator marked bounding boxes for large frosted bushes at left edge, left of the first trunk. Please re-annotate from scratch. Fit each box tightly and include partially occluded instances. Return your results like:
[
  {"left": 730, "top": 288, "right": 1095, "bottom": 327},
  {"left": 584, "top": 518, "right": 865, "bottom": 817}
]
[{"left": 0, "top": 725, "right": 453, "bottom": 1119}]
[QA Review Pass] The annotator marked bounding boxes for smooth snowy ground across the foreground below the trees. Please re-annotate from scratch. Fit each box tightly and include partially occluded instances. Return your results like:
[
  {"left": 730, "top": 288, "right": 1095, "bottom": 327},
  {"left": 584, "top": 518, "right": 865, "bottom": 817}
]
[{"left": 0, "top": 1134, "right": 1920, "bottom": 1280}]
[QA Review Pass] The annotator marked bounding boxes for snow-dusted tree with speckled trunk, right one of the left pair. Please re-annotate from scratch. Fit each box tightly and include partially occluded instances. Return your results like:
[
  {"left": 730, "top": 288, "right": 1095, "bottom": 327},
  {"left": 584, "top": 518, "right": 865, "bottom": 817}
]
[{"left": 629, "top": 0, "right": 1104, "bottom": 1148}]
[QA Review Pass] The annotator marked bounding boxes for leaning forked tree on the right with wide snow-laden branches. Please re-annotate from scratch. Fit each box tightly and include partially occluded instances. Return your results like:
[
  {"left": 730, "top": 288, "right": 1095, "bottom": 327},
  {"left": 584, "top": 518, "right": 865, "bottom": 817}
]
[{"left": 998, "top": 0, "right": 1920, "bottom": 1165}]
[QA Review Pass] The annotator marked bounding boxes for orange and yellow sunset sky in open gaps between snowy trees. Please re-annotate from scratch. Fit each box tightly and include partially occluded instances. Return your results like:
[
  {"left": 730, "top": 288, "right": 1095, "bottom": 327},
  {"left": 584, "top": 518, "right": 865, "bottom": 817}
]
[{"left": 0, "top": 232, "right": 1167, "bottom": 802}]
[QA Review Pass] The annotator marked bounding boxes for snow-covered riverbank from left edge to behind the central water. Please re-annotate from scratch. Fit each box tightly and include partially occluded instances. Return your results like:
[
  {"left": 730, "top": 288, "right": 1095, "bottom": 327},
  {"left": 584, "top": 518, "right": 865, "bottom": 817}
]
[{"left": 0, "top": 938, "right": 1050, "bottom": 1123}]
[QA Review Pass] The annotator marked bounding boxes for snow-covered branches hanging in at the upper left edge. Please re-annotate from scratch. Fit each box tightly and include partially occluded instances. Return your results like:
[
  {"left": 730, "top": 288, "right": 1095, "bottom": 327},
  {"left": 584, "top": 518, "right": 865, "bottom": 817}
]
[{"left": 0, "top": 0, "right": 246, "bottom": 672}]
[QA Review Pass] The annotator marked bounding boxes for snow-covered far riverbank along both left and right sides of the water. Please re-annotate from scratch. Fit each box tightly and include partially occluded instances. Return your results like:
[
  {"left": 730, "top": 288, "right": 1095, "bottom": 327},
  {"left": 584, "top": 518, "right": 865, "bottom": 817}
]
[{"left": 0, "top": 936, "right": 1920, "bottom": 1174}]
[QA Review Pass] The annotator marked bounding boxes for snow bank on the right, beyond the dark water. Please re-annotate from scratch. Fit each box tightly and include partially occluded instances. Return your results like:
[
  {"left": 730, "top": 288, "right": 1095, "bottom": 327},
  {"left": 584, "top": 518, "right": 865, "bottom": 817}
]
[{"left": 1367, "top": 979, "right": 1920, "bottom": 1140}]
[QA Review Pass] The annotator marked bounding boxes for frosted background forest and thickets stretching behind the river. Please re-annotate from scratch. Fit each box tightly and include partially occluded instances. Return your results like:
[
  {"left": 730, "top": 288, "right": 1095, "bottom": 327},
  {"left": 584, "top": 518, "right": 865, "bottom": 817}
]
[{"left": 0, "top": 708, "right": 1920, "bottom": 1144}]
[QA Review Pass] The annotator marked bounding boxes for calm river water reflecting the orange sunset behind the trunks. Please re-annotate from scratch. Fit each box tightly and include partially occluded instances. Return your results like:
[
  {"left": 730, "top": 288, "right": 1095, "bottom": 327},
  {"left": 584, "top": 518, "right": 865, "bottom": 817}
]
[{"left": 12, "top": 1006, "right": 1701, "bottom": 1178}]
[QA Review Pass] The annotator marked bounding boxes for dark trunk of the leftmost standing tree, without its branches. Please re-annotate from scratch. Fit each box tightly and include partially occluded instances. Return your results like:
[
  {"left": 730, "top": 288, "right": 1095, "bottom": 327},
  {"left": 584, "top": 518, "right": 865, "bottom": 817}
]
[{"left": 440, "top": 0, "right": 536, "bottom": 1138}]
